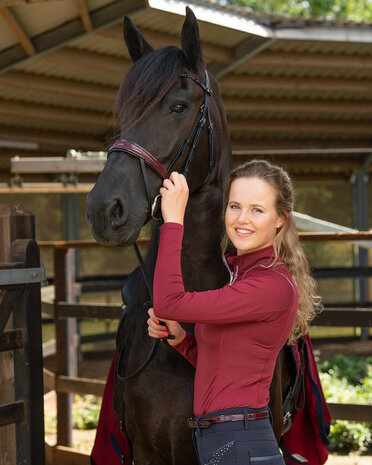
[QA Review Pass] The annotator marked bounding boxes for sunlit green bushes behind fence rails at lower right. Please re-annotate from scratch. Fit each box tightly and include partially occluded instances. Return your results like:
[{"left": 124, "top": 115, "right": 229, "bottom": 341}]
[{"left": 318, "top": 354, "right": 372, "bottom": 454}]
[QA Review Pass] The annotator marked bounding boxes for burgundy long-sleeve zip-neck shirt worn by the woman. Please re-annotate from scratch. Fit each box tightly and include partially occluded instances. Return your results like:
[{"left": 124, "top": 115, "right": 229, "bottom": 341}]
[{"left": 154, "top": 223, "right": 298, "bottom": 415}]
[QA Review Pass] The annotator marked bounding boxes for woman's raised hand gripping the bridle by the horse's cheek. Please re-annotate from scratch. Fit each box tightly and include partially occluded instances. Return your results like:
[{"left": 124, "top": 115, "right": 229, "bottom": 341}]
[{"left": 159, "top": 171, "right": 189, "bottom": 224}]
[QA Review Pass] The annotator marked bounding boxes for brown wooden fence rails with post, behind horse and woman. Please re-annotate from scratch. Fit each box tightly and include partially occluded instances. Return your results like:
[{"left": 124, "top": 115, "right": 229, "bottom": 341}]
[{"left": 38, "top": 231, "right": 372, "bottom": 465}]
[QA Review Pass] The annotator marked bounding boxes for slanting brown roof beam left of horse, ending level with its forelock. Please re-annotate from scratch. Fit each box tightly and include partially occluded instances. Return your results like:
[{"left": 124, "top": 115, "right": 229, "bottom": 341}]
[{"left": 0, "top": 71, "right": 117, "bottom": 104}]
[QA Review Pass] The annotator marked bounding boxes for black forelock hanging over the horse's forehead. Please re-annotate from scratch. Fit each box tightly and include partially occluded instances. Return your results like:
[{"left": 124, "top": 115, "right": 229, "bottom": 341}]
[{"left": 115, "top": 46, "right": 187, "bottom": 129}]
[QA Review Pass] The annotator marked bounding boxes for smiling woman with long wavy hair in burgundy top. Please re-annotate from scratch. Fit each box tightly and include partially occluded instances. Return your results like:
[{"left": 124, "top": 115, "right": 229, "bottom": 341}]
[{"left": 148, "top": 160, "right": 319, "bottom": 465}]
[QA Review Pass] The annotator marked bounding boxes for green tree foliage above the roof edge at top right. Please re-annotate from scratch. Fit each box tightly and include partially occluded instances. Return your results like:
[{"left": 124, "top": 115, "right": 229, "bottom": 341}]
[{"left": 227, "top": 0, "right": 372, "bottom": 22}]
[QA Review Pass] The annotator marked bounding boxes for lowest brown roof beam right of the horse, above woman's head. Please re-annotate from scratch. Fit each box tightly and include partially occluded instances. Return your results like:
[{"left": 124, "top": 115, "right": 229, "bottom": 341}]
[{"left": 228, "top": 118, "right": 371, "bottom": 139}]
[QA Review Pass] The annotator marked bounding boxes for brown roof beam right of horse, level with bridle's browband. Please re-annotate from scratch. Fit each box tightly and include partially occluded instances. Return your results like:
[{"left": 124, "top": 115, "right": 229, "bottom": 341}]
[{"left": 219, "top": 74, "right": 372, "bottom": 94}]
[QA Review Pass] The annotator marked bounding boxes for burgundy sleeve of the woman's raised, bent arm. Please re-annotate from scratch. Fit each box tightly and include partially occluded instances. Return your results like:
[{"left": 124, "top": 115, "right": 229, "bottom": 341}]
[{"left": 154, "top": 223, "right": 296, "bottom": 324}]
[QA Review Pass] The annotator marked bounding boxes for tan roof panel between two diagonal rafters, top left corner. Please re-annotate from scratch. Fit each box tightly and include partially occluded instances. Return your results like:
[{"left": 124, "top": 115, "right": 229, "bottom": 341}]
[{"left": 12, "top": 0, "right": 79, "bottom": 37}]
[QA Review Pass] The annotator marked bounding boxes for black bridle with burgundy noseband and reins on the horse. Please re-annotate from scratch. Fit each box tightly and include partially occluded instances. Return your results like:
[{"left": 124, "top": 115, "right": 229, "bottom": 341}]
[{"left": 114, "top": 71, "right": 214, "bottom": 382}]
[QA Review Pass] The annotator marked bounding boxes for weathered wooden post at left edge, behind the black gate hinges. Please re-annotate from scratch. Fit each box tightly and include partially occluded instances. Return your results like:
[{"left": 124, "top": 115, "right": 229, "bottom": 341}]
[{"left": 0, "top": 205, "right": 35, "bottom": 465}]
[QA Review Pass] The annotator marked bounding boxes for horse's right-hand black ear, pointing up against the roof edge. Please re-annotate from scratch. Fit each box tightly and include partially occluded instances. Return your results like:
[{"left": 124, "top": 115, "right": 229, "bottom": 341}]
[{"left": 181, "top": 6, "right": 204, "bottom": 69}]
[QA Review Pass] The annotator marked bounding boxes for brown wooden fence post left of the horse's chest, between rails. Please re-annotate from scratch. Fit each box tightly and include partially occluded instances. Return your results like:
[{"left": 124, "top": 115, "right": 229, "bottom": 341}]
[{"left": 54, "top": 248, "right": 77, "bottom": 447}]
